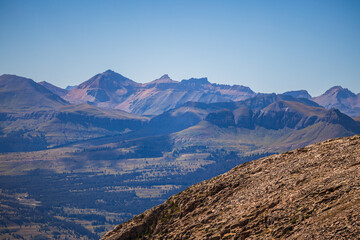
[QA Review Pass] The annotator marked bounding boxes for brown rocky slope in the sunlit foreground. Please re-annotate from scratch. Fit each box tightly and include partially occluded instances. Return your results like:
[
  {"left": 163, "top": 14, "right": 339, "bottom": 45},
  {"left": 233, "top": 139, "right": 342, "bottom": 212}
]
[{"left": 102, "top": 135, "right": 360, "bottom": 239}]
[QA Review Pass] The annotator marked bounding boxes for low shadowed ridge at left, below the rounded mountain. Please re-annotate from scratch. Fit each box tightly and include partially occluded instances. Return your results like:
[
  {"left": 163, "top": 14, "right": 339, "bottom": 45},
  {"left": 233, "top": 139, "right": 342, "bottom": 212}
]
[{"left": 0, "top": 104, "right": 148, "bottom": 152}]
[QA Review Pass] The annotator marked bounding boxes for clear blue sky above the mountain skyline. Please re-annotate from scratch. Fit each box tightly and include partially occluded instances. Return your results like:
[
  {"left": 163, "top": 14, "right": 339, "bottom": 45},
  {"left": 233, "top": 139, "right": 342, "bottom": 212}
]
[{"left": 0, "top": 0, "right": 360, "bottom": 96}]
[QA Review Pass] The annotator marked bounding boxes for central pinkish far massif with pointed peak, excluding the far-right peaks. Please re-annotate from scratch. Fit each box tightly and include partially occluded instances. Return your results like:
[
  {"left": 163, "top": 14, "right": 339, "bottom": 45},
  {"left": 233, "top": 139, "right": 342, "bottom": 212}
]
[{"left": 64, "top": 70, "right": 256, "bottom": 115}]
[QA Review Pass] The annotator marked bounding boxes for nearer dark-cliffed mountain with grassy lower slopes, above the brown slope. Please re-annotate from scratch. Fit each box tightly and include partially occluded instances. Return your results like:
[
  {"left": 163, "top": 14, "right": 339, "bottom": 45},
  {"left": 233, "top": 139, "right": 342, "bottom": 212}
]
[{"left": 123, "top": 94, "right": 360, "bottom": 158}]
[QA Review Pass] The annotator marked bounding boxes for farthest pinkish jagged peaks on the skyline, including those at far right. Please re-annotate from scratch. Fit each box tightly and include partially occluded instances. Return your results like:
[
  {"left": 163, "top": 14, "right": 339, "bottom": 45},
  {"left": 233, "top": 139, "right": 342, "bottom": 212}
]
[{"left": 31, "top": 70, "right": 360, "bottom": 117}]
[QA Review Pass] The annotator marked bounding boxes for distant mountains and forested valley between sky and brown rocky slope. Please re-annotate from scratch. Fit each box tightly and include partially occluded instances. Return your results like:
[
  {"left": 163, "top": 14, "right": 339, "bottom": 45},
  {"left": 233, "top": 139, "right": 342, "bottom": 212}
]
[{"left": 0, "top": 70, "right": 360, "bottom": 239}]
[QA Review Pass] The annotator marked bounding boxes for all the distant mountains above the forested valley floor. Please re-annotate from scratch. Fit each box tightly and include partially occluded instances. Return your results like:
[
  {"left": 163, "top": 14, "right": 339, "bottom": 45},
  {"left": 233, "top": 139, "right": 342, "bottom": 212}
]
[{"left": 0, "top": 70, "right": 359, "bottom": 154}]
